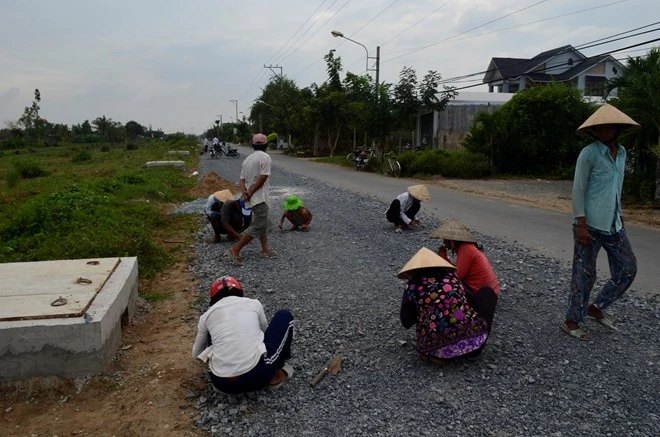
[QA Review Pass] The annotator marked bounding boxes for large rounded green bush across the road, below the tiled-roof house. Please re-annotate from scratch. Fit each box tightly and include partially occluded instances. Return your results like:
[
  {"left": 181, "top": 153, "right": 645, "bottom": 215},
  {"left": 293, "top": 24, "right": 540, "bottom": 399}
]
[{"left": 463, "top": 84, "right": 594, "bottom": 175}]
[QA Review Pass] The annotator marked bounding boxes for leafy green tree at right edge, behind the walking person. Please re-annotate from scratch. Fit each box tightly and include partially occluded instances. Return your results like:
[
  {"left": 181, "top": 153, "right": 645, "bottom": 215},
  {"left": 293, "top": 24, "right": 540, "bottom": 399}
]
[{"left": 606, "top": 47, "right": 660, "bottom": 200}]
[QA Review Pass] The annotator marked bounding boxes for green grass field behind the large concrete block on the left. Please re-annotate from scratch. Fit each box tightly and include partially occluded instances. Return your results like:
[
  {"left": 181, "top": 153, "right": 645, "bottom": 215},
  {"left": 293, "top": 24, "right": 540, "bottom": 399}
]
[{"left": 0, "top": 140, "right": 197, "bottom": 278}]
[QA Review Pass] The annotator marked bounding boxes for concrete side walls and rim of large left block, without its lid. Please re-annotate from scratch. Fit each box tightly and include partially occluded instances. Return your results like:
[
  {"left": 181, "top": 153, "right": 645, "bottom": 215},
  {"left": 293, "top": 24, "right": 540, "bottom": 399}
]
[{"left": 0, "top": 257, "right": 138, "bottom": 382}]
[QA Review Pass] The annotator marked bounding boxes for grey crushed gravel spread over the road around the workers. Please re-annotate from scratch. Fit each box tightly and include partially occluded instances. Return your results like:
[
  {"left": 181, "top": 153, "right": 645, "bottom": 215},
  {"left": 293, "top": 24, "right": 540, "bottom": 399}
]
[{"left": 173, "top": 155, "right": 660, "bottom": 437}]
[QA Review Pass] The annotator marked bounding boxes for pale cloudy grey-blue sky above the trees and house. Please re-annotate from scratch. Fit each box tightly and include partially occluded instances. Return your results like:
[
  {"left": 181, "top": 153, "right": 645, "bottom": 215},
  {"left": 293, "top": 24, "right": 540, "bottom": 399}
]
[{"left": 0, "top": 0, "right": 660, "bottom": 133}]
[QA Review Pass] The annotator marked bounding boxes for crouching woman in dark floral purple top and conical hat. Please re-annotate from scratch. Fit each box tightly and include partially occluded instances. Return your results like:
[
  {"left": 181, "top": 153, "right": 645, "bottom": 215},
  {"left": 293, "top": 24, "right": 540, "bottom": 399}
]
[{"left": 397, "top": 247, "right": 497, "bottom": 365}]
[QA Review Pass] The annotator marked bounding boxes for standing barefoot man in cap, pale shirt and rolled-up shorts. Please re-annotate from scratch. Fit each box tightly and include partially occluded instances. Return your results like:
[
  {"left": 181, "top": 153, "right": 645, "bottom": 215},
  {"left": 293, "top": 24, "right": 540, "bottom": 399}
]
[{"left": 225, "top": 134, "right": 276, "bottom": 265}]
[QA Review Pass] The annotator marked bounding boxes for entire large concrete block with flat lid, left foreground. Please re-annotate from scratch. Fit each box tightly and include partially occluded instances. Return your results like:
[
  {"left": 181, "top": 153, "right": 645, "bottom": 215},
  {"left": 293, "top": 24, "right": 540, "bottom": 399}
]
[{"left": 0, "top": 257, "right": 138, "bottom": 381}]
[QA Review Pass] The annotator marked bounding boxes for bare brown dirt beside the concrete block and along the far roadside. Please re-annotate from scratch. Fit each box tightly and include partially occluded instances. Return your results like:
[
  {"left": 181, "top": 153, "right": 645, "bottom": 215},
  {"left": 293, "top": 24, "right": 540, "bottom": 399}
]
[{"left": 0, "top": 173, "right": 660, "bottom": 437}]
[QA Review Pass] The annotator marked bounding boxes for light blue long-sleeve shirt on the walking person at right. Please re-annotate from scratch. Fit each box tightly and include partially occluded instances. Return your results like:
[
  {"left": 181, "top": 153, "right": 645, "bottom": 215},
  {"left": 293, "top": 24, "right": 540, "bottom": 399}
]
[{"left": 572, "top": 141, "right": 626, "bottom": 234}]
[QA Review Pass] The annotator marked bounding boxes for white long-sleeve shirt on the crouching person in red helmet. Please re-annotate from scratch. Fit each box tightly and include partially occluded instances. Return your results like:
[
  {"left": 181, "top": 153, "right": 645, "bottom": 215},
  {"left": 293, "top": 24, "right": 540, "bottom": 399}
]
[{"left": 192, "top": 296, "right": 268, "bottom": 378}]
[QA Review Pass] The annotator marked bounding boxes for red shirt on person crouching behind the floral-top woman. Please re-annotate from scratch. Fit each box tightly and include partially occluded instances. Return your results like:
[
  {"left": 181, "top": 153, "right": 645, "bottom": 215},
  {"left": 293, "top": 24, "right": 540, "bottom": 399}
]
[{"left": 456, "top": 243, "right": 500, "bottom": 296}]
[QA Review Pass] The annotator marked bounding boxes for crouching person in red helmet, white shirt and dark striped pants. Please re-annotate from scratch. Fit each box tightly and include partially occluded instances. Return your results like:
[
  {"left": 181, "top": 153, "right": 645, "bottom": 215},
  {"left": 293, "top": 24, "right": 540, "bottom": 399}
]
[{"left": 192, "top": 276, "right": 293, "bottom": 394}]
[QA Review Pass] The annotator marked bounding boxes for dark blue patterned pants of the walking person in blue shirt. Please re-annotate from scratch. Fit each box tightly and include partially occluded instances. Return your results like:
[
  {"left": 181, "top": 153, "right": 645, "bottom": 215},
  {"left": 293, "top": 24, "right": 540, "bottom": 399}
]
[{"left": 566, "top": 226, "right": 637, "bottom": 322}]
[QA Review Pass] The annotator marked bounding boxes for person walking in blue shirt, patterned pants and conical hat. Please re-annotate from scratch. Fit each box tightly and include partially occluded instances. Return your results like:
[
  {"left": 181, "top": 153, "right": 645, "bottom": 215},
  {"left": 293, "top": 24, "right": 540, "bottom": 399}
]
[{"left": 561, "top": 104, "right": 639, "bottom": 340}]
